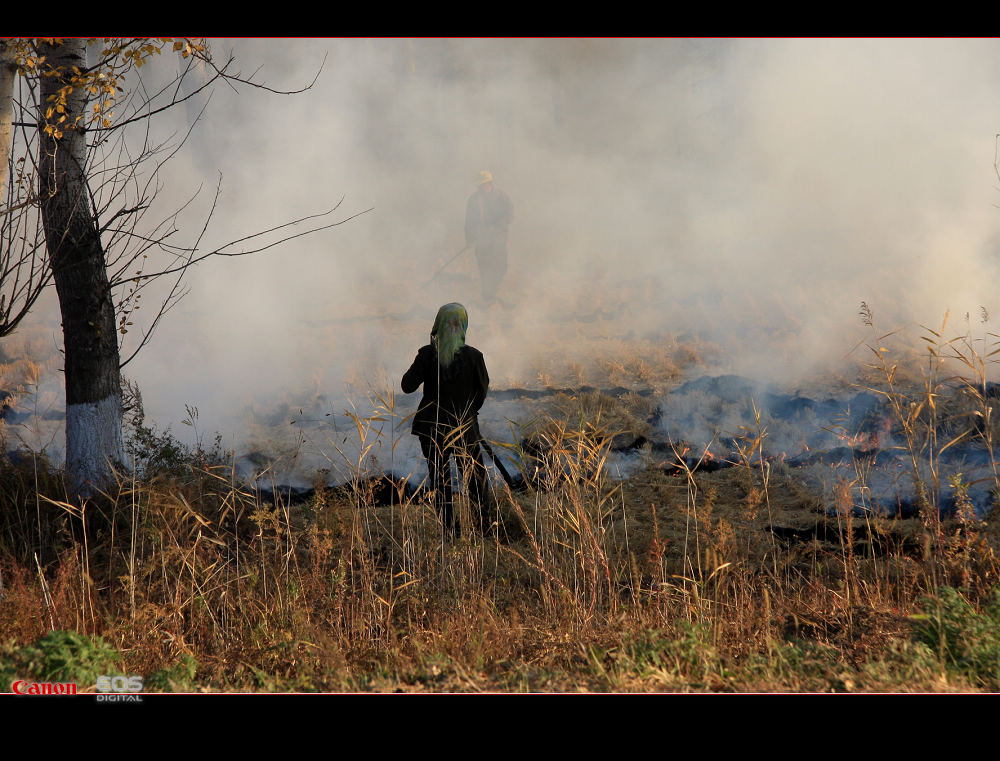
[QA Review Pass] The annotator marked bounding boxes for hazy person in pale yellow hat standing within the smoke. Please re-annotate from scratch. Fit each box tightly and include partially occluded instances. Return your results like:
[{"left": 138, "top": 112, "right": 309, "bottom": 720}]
[{"left": 465, "top": 170, "right": 514, "bottom": 304}]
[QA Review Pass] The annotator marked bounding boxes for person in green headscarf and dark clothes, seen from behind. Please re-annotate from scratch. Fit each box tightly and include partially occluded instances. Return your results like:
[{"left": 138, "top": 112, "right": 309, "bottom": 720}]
[{"left": 402, "top": 303, "right": 491, "bottom": 537}]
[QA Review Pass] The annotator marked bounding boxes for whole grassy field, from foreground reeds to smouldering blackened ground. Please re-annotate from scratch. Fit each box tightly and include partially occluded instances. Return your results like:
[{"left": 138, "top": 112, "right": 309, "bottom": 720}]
[{"left": 0, "top": 308, "right": 1000, "bottom": 692}]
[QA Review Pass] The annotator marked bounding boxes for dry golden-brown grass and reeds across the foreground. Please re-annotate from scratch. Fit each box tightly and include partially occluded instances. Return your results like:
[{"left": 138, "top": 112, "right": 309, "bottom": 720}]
[{"left": 0, "top": 314, "right": 1000, "bottom": 692}]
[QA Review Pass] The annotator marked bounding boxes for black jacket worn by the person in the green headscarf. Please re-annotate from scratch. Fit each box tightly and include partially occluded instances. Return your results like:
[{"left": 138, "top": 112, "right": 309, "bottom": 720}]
[{"left": 402, "top": 345, "right": 490, "bottom": 441}]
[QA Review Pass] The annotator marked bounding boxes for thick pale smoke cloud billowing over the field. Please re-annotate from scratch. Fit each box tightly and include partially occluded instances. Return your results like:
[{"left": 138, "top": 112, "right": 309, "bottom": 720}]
[{"left": 5, "top": 40, "right": 1000, "bottom": 492}]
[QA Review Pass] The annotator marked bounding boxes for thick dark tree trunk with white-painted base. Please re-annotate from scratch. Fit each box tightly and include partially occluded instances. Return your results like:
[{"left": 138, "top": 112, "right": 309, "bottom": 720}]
[{"left": 39, "top": 39, "right": 124, "bottom": 498}]
